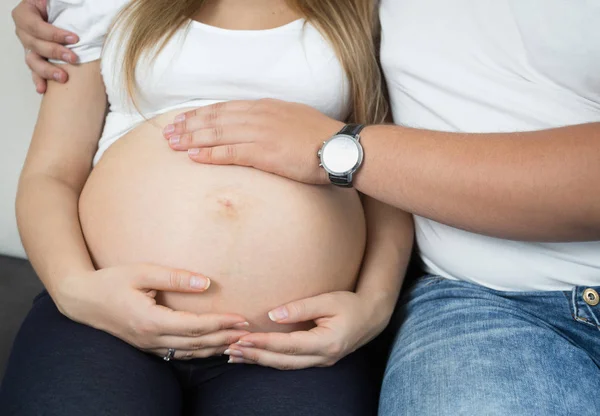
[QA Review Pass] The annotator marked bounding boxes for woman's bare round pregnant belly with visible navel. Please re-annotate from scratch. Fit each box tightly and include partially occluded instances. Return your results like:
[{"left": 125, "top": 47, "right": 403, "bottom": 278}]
[{"left": 79, "top": 109, "right": 366, "bottom": 332}]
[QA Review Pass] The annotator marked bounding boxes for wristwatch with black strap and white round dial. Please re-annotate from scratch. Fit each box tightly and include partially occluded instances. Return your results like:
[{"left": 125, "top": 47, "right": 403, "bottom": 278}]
[{"left": 317, "top": 124, "right": 365, "bottom": 188}]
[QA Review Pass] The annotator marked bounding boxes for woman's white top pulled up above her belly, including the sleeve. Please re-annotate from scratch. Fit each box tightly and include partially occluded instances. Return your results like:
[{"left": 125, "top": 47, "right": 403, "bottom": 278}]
[{"left": 48, "top": 0, "right": 350, "bottom": 164}]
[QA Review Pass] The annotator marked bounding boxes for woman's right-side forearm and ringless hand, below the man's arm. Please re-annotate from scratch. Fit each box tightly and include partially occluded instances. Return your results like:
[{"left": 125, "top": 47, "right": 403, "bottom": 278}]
[{"left": 225, "top": 197, "right": 414, "bottom": 370}]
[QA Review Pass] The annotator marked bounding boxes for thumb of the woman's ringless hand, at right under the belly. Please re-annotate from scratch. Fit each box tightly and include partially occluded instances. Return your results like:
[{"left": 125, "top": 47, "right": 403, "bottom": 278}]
[{"left": 269, "top": 294, "right": 332, "bottom": 324}]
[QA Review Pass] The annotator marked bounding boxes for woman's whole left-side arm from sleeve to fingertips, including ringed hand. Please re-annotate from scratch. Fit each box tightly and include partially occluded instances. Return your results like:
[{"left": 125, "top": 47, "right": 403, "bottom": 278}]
[{"left": 17, "top": 61, "right": 247, "bottom": 358}]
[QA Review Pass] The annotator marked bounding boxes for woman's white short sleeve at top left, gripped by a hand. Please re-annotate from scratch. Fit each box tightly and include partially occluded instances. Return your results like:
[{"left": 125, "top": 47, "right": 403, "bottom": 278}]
[{"left": 47, "top": 0, "right": 130, "bottom": 63}]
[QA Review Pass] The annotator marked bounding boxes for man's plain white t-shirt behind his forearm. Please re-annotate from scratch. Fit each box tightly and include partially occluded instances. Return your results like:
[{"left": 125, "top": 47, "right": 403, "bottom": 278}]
[{"left": 381, "top": 0, "right": 600, "bottom": 291}]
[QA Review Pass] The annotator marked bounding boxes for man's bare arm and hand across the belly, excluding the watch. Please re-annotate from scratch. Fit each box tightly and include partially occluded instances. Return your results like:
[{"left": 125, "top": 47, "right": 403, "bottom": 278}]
[{"left": 165, "top": 100, "right": 600, "bottom": 242}]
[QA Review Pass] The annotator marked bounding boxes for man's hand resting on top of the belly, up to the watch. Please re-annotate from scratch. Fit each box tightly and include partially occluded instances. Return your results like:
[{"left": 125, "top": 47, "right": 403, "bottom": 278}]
[{"left": 164, "top": 99, "right": 344, "bottom": 185}]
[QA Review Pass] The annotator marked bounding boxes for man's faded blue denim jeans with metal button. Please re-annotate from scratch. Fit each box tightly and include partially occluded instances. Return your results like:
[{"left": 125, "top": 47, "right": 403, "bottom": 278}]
[{"left": 380, "top": 276, "right": 600, "bottom": 416}]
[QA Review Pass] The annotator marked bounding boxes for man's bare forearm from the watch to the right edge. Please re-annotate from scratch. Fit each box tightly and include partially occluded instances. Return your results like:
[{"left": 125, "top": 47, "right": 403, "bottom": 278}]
[{"left": 355, "top": 123, "right": 600, "bottom": 241}]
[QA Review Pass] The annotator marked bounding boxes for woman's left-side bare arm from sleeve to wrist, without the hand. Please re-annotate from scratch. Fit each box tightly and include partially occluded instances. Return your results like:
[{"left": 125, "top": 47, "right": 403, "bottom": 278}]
[{"left": 17, "top": 61, "right": 106, "bottom": 296}]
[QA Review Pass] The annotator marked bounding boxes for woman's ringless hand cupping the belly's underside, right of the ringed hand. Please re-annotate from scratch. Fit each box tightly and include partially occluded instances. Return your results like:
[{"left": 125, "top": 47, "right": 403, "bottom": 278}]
[{"left": 220, "top": 292, "right": 390, "bottom": 370}]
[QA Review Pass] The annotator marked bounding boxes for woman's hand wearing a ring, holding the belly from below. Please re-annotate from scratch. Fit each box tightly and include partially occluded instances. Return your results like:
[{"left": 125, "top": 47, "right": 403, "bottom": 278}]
[{"left": 57, "top": 264, "right": 248, "bottom": 360}]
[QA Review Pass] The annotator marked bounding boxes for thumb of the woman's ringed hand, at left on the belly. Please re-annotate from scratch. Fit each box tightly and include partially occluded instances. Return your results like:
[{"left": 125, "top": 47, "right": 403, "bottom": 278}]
[{"left": 135, "top": 264, "right": 210, "bottom": 292}]
